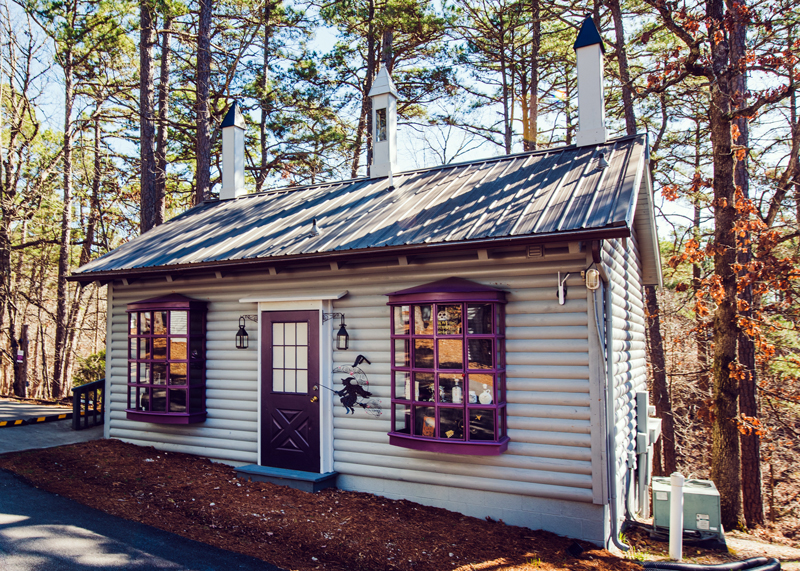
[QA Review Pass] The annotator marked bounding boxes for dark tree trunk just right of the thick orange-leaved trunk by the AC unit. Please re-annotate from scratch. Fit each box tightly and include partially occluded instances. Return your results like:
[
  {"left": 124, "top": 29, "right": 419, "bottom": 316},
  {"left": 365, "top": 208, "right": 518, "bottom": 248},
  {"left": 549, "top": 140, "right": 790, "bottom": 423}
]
[{"left": 731, "top": 2, "right": 764, "bottom": 527}]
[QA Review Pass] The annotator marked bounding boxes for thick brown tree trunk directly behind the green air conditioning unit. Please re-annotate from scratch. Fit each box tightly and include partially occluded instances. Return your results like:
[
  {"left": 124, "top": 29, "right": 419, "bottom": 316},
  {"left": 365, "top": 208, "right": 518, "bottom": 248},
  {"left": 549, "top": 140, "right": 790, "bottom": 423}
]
[{"left": 706, "top": 0, "right": 742, "bottom": 529}]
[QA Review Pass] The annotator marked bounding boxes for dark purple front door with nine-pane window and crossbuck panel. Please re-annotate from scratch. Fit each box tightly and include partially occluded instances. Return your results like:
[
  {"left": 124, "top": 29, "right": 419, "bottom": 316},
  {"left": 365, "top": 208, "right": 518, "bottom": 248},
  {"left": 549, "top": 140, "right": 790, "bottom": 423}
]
[{"left": 261, "top": 311, "right": 320, "bottom": 472}]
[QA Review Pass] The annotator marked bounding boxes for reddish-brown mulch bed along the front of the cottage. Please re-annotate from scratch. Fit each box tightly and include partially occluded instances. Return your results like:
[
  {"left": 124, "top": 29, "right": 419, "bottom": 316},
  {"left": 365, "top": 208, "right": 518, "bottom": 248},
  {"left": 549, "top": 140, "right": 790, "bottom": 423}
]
[{"left": 0, "top": 440, "right": 641, "bottom": 571}]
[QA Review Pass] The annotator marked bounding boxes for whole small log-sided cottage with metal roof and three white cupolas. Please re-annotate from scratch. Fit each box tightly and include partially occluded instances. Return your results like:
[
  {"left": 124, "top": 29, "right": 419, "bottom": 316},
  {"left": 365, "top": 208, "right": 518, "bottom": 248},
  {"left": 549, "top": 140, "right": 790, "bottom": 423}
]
[{"left": 71, "top": 20, "right": 661, "bottom": 544}]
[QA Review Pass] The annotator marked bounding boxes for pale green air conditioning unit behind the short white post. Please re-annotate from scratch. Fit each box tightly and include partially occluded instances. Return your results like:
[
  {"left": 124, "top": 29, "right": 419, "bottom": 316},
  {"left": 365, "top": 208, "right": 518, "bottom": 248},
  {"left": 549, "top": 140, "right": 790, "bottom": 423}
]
[{"left": 653, "top": 478, "right": 723, "bottom": 539}]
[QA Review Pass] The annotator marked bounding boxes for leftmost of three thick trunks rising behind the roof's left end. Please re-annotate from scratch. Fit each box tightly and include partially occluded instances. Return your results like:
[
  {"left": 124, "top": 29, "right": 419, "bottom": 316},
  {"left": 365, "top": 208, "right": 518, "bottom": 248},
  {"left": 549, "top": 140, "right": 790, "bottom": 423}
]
[{"left": 139, "top": 0, "right": 158, "bottom": 234}]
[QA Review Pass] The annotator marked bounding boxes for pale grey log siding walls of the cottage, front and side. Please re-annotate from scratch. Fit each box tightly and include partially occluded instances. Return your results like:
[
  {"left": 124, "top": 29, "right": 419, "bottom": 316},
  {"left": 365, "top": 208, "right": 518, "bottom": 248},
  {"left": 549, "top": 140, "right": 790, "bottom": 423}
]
[{"left": 107, "top": 248, "right": 644, "bottom": 543}]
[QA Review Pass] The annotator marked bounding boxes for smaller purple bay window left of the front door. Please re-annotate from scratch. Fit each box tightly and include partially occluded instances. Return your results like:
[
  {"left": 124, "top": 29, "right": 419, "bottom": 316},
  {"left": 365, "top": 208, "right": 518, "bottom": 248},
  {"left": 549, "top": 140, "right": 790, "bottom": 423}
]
[{"left": 125, "top": 294, "right": 206, "bottom": 424}]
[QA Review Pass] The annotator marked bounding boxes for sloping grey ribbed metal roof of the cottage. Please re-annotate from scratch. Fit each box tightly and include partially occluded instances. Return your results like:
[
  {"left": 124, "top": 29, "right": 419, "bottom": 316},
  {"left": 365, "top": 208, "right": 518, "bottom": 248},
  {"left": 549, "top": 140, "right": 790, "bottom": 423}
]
[{"left": 72, "top": 135, "right": 657, "bottom": 281}]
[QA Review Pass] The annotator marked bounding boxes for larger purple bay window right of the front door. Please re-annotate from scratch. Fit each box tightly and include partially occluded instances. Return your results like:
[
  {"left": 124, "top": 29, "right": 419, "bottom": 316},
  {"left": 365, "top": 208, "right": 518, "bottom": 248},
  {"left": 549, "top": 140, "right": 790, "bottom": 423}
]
[{"left": 388, "top": 278, "right": 508, "bottom": 455}]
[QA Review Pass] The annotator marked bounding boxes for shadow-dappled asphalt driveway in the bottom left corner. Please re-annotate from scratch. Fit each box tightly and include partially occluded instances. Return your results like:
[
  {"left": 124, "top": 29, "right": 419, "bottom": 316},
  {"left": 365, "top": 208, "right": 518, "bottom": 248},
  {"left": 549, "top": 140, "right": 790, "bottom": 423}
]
[{"left": 0, "top": 470, "right": 282, "bottom": 571}]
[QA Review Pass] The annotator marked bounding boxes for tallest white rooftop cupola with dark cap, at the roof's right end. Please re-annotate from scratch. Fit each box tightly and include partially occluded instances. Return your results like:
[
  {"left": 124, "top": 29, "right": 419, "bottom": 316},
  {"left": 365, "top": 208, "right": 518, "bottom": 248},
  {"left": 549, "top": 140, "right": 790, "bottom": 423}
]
[{"left": 573, "top": 18, "right": 608, "bottom": 147}]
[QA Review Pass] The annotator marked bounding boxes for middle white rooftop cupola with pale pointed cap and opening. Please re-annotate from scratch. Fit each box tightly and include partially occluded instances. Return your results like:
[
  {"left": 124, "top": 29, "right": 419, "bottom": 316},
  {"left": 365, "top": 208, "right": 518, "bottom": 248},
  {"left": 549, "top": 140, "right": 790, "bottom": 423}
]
[{"left": 369, "top": 65, "right": 397, "bottom": 178}]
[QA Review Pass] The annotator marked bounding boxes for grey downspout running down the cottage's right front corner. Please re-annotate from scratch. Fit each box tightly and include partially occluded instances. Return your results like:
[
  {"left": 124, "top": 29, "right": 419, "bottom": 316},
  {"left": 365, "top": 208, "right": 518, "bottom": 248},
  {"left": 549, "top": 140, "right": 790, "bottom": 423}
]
[{"left": 592, "top": 262, "right": 630, "bottom": 551}]
